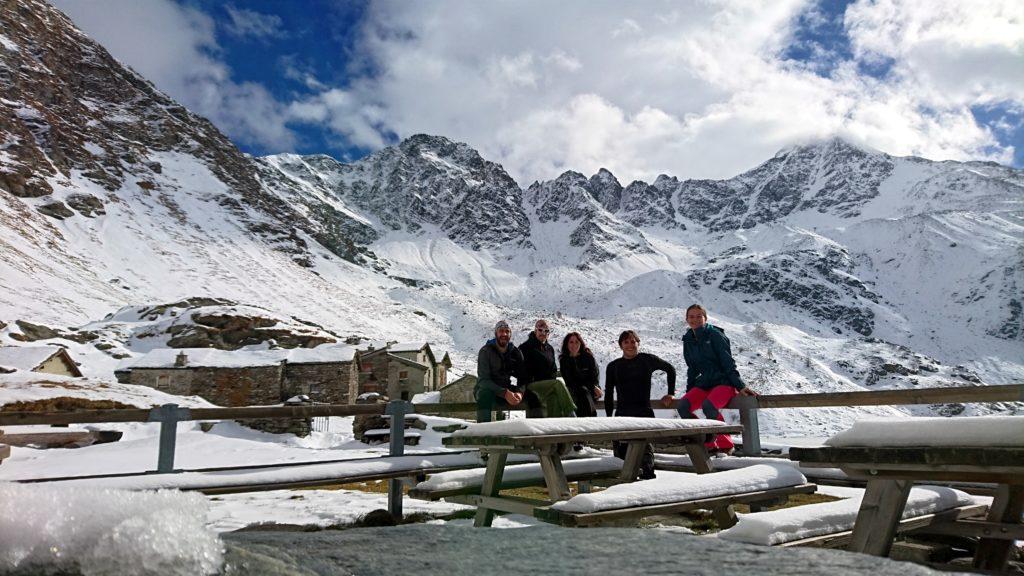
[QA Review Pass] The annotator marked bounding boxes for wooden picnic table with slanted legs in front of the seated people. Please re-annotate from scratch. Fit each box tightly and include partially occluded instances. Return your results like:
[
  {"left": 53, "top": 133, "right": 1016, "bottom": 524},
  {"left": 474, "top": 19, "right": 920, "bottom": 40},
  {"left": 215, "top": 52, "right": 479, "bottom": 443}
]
[{"left": 443, "top": 418, "right": 742, "bottom": 527}]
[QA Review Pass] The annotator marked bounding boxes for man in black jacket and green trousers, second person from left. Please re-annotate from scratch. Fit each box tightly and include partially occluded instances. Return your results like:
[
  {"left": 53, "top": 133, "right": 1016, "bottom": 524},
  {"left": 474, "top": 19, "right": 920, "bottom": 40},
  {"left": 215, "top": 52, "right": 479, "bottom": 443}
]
[{"left": 519, "top": 319, "right": 575, "bottom": 418}]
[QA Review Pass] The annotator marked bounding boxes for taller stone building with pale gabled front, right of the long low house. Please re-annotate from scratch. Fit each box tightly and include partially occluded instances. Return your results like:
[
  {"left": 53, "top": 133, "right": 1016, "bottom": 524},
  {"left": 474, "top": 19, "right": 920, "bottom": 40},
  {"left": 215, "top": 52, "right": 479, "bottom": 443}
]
[{"left": 359, "top": 342, "right": 452, "bottom": 400}]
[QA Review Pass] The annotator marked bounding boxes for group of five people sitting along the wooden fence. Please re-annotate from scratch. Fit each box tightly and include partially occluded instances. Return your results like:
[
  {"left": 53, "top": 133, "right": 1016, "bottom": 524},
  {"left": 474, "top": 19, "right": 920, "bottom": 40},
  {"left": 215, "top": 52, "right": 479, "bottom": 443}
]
[{"left": 475, "top": 304, "right": 754, "bottom": 479}]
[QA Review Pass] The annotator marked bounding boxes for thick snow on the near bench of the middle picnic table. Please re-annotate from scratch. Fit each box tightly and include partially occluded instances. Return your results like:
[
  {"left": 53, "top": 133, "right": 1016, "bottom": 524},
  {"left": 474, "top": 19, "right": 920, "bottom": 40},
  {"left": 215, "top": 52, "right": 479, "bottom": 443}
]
[{"left": 551, "top": 463, "right": 807, "bottom": 513}]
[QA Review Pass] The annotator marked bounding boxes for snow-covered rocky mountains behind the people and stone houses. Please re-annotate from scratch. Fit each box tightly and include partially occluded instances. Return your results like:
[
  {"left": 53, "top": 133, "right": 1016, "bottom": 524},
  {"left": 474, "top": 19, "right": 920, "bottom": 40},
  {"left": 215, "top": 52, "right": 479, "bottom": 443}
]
[{"left": 0, "top": 0, "right": 1024, "bottom": 434}]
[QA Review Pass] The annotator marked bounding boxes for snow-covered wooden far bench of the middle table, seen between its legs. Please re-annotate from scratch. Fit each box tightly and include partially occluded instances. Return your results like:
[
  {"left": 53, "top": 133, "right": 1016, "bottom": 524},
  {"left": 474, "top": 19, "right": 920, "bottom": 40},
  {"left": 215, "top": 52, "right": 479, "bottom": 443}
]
[{"left": 409, "top": 457, "right": 623, "bottom": 503}]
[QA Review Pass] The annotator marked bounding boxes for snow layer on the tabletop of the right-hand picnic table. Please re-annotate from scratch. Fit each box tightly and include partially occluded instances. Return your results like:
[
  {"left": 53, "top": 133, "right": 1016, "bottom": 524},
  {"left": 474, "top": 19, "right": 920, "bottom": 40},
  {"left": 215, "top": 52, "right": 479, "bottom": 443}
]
[{"left": 825, "top": 416, "right": 1024, "bottom": 448}]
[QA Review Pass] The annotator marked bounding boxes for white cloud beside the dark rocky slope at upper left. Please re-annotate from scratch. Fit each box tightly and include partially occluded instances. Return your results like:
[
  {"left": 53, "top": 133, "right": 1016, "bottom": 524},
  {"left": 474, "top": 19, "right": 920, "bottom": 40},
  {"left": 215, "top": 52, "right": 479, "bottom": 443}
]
[{"left": 54, "top": 0, "right": 295, "bottom": 151}]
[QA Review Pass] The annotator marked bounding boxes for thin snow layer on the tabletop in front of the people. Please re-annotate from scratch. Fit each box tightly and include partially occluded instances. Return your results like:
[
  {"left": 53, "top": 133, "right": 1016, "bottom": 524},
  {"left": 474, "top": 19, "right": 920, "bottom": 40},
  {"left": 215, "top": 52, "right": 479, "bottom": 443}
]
[{"left": 452, "top": 417, "right": 728, "bottom": 438}]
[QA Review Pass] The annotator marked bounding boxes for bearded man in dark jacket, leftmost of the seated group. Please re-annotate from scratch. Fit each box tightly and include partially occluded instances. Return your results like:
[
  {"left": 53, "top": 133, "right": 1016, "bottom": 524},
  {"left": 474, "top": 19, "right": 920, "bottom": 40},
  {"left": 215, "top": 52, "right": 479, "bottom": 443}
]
[{"left": 473, "top": 320, "right": 524, "bottom": 422}]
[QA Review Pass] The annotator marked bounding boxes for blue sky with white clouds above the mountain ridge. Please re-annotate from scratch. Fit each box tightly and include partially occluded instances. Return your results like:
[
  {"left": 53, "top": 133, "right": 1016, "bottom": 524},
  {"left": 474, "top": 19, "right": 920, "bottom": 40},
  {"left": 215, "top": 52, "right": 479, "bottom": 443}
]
[{"left": 55, "top": 0, "right": 1024, "bottom": 180}]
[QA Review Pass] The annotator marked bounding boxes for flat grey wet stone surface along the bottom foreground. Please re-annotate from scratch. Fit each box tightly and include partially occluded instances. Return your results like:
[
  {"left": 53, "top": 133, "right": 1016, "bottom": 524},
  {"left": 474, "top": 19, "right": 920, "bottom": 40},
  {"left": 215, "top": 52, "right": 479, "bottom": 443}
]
[{"left": 222, "top": 525, "right": 950, "bottom": 576}]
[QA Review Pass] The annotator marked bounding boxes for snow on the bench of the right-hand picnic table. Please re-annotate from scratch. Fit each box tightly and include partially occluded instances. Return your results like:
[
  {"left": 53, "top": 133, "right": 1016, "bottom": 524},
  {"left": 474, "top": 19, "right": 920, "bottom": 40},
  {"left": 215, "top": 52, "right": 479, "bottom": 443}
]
[{"left": 717, "top": 481, "right": 980, "bottom": 546}]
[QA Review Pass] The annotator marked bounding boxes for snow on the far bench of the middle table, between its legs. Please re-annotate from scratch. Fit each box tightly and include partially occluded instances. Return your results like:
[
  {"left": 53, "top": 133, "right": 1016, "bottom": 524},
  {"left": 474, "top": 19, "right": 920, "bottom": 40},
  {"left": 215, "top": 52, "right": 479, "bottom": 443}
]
[{"left": 409, "top": 456, "right": 623, "bottom": 500}]
